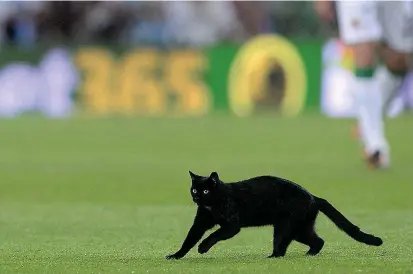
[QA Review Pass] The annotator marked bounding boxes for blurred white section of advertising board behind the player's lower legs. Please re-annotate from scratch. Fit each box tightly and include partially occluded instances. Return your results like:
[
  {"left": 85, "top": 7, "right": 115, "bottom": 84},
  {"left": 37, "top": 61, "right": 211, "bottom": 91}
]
[{"left": 321, "top": 39, "right": 413, "bottom": 118}]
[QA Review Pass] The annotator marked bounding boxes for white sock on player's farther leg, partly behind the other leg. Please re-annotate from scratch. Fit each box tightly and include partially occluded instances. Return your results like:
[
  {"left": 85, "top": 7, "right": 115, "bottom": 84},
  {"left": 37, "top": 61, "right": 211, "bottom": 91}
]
[{"left": 376, "top": 66, "right": 404, "bottom": 117}]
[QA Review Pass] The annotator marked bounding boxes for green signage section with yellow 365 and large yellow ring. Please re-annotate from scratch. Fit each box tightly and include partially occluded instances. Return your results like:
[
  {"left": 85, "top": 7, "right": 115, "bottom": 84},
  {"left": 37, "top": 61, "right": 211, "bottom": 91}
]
[{"left": 0, "top": 35, "right": 322, "bottom": 117}]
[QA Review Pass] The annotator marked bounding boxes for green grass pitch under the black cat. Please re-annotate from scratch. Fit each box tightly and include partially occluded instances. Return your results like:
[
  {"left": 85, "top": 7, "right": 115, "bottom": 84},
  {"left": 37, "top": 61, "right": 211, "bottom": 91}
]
[{"left": 0, "top": 114, "right": 413, "bottom": 274}]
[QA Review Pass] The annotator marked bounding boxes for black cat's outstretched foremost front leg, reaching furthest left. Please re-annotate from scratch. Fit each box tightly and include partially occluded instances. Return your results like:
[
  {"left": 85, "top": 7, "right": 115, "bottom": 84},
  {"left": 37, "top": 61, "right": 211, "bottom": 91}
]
[{"left": 166, "top": 209, "right": 215, "bottom": 260}]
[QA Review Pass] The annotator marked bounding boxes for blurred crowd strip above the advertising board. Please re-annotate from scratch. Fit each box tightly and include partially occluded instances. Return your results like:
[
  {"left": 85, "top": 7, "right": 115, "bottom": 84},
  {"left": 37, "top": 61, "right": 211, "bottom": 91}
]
[{"left": 0, "top": 1, "right": 319, "bottom": 46}]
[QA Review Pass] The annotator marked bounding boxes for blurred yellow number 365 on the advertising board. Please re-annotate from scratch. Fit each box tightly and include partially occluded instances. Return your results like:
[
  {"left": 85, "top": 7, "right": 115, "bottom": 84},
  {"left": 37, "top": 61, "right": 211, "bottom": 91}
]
[{"left": 75, "top": 48, "right": 211, "bottom": 116}]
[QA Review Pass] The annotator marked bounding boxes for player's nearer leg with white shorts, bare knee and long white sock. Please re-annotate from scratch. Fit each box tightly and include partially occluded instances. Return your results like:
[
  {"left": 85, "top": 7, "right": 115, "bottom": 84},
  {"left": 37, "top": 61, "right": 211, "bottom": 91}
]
[{"left": 337, "top": 1, "right": 388, "bottom": 167}]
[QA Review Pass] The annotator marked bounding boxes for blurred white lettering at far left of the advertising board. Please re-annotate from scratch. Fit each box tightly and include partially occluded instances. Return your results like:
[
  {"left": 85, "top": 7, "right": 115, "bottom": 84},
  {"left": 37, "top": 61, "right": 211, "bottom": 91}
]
[{"left": 0, "top": 48, "right": 79, "bottom": 117}]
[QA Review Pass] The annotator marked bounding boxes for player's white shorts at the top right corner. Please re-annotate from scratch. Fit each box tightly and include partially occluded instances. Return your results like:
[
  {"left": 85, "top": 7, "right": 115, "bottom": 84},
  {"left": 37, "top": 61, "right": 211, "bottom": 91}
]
[{"left": 337, "top": 0, "right": 413, "bottom": 53}]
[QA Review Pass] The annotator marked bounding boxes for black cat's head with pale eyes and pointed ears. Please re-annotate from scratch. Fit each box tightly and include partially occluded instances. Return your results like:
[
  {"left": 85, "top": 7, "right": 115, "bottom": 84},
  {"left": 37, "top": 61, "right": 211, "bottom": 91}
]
[{"left": 189, "top": 171, "right": 222, "bottom": 206}]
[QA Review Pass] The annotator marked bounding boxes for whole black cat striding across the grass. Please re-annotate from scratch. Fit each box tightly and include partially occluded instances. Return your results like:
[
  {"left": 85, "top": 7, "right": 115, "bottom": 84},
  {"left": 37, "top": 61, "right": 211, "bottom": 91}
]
[{"left": 166, "top": 171, "right": 383, "bottom": 259}]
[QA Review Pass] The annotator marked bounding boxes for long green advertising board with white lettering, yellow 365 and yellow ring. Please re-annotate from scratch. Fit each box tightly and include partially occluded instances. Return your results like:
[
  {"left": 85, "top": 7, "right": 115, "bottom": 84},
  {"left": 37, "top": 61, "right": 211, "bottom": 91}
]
[{"left": 0, "top": 35, "right": 323, "bottom": 118}]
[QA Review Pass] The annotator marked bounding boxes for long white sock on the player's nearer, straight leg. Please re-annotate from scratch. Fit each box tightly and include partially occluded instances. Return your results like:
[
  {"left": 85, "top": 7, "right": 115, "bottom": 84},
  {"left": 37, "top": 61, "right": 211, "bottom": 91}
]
[{"left": 353, "top": 77, "right": 388, "bottom": 154}]
